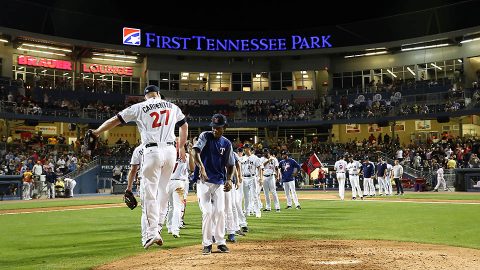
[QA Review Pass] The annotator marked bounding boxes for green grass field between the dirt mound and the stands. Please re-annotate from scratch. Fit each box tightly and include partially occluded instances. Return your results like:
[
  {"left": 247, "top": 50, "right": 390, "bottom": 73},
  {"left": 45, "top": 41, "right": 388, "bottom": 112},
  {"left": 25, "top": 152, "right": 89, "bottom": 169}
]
[{"left": 0, "top": 192, "right": 480, "bottom": 269}]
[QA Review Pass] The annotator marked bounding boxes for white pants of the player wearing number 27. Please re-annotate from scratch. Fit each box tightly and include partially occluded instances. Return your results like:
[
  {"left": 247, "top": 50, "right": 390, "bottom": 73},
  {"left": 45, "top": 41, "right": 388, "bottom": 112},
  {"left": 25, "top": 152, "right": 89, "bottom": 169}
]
[{"left": 141, "top": 143, "right": 177, "bottom": 244}]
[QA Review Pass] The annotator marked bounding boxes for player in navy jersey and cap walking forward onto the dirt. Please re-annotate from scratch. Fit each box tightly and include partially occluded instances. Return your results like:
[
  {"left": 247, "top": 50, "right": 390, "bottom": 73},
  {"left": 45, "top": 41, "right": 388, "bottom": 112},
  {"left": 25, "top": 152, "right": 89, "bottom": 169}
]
[{"left": 193, "top": 114, "right": 235, "bottom": 255}]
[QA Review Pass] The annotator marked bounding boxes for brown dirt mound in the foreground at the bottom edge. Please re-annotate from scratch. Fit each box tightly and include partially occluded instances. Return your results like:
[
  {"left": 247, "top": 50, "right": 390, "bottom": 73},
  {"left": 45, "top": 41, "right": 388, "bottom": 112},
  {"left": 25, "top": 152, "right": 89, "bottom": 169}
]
[{"left": 96, "top": 240, "right": 480, "bottom": 270}]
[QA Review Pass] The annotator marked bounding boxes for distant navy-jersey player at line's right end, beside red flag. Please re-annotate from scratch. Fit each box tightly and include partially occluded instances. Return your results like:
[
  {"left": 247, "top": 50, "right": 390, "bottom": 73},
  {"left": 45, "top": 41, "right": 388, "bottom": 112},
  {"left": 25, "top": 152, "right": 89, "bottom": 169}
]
[{"left": 279, "top": 150, "right": 302, "bottom": 209}]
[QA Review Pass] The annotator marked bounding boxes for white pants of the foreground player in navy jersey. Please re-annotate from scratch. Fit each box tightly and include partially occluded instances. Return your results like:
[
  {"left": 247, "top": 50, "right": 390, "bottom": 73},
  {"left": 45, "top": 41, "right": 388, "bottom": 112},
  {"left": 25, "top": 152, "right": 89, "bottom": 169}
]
[{"left": 197, "top": 181, "right": 225, "bottom": 246}]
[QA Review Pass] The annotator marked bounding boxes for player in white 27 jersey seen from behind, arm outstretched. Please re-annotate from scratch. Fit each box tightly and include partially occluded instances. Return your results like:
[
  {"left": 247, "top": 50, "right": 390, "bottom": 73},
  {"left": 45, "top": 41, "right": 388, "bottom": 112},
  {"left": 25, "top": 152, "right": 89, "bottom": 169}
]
[{"left": 93, "top": 85, "right": 188, "bottom": 249}]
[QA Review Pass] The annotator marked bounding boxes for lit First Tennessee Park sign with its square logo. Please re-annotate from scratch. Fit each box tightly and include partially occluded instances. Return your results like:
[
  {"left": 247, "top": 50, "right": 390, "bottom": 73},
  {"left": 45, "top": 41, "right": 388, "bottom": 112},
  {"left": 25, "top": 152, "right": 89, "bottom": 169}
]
[{"left": 123, "top": 27, "right": 332, "bottom": 52}]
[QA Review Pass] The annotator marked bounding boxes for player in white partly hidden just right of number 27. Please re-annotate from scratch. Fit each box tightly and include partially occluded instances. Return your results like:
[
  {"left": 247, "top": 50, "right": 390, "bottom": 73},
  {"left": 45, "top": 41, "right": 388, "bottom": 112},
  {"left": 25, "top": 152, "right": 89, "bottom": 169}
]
[{"left": 167, "top": 142, "right": 195, "bottom": 238}]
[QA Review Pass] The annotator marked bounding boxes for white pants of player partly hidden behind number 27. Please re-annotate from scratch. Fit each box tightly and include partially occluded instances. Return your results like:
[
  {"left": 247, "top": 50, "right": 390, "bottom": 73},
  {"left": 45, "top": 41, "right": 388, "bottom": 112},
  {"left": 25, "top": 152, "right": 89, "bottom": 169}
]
[{"left": 167, "top": 180, "right": 188, "bottom": 235}]
